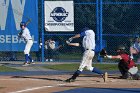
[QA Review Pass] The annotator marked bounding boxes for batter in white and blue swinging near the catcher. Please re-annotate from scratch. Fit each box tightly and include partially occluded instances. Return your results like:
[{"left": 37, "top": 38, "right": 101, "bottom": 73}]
[{"left": 66, "top": 27, "right": 107, "bottom": 82}]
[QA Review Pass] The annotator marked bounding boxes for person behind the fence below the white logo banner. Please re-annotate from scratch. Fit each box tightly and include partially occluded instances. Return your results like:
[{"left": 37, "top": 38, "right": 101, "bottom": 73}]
[{"left": 45, "top": 38, "right": 55, "bottom": 62}]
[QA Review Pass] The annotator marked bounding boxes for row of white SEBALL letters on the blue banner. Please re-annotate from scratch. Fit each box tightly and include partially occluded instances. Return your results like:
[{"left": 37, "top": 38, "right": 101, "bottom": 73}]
[{"left": 0, "top": 35, "right": 37, "bottom": 43}]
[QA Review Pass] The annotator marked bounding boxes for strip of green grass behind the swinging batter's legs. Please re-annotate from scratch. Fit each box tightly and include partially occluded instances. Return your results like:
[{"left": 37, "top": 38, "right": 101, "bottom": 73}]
[{"left": 44, "top": 63, "right": 118, "bottom": 71}]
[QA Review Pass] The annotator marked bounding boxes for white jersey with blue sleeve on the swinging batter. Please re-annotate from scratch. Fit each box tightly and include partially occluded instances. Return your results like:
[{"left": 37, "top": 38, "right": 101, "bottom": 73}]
[{"left": 80, "top": 30, "right": 95, "bottom": 50}]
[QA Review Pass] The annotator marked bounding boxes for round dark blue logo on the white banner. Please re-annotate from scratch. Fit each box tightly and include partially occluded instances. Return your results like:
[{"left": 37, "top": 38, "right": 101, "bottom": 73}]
[{"left": 50, "top": 7, "right": 69, "bottom": 22}]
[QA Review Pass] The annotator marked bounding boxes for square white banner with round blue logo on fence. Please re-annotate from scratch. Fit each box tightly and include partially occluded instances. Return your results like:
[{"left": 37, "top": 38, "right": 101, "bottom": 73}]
[{"left": 44, "top": 1, "right": 74, "bottom": 32}]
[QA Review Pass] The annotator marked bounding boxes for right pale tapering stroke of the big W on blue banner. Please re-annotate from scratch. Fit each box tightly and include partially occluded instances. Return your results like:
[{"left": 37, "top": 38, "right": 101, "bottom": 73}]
[{"left": 11, "top": 0, "right": 25, "bottom": 30}]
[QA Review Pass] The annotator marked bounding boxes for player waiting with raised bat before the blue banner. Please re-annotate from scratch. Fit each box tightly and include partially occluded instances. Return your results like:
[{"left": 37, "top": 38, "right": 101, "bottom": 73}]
[{"left": 18, "top": 22, "right": 34, "bottom": 66}]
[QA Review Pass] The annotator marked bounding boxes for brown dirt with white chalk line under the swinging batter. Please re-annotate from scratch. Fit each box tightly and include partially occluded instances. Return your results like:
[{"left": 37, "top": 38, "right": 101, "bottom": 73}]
[{"left": 0, "top": 75, "right": 140, "bottom": 93}]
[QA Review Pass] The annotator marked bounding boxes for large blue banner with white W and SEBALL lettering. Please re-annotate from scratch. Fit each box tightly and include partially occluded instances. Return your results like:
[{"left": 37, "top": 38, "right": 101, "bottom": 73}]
[{"left": 0, "top": 0, "right": 38, "bottom": 51}]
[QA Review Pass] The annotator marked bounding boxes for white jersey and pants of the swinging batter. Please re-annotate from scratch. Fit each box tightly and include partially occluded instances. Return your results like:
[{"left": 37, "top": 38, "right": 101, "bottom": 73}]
[{"left": 78, "top": 30, "right": 95, "bottom": 71}]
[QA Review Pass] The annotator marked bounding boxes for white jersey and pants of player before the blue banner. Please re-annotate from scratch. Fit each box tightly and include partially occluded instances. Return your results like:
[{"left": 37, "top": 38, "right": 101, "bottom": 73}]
[{"left": 21, "top": 27, "right": 33, "bottom": 55}]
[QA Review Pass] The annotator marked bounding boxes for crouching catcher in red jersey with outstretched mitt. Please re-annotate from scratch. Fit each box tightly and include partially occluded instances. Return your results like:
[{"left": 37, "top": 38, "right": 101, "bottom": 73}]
[{"left": 100, "top": 45, "right": 140, "bottom": 80}]
